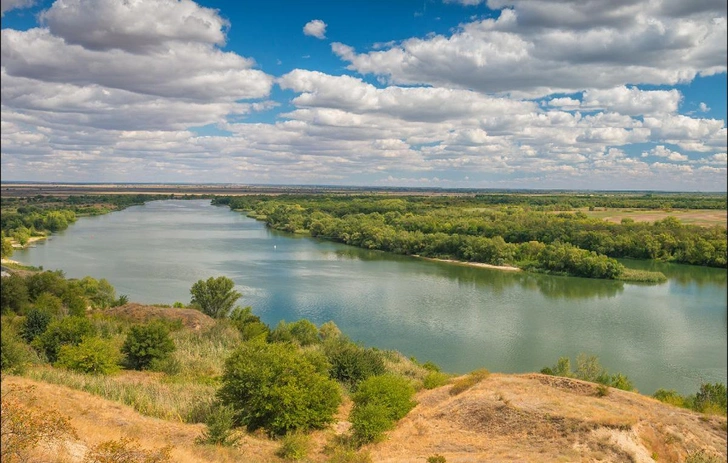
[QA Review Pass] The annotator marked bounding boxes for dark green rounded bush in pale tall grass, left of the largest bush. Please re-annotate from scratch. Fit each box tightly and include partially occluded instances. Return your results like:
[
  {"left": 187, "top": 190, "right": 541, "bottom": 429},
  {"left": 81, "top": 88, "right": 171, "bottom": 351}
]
[{"left": 121, "top": 321, "right": 175, "bottom": 370}]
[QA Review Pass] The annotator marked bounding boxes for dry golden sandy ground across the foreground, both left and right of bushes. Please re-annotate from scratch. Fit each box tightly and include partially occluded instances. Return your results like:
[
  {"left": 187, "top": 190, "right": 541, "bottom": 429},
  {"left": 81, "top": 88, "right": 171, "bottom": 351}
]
[{"left": 3, "top": 374, "right": 726, "bottom": 463}]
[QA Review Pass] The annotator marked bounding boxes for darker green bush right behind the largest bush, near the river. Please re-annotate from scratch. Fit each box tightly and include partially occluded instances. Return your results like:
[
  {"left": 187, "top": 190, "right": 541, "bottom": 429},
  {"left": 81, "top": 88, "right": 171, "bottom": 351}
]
[{"left": 324, "top": 338, "right": 385, "bottom": 389}]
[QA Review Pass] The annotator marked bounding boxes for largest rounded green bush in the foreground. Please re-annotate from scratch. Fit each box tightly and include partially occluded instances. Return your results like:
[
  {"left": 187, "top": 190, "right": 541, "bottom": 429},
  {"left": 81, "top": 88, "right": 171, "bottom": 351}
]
[{"left": 218, "top": 340, "right": 341, "bottom": 434}]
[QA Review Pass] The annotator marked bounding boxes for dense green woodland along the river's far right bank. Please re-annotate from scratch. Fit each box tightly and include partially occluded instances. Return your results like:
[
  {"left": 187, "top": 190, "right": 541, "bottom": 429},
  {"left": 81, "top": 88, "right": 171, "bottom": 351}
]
[{"left": 212, "top": 195, "right": 727, "bottom": 282}]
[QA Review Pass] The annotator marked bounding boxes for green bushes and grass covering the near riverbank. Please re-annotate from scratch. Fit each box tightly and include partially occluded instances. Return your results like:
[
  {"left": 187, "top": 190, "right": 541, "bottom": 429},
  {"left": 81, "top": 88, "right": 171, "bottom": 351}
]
[{"left": 0, "top": 271, "right": 726, "bottom": 462}]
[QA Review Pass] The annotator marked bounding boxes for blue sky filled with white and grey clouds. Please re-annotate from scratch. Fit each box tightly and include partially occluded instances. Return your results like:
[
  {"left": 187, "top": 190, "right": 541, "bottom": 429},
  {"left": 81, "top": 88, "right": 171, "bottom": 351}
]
[{"left": 0, "top": 0, "right": 728, "bottom": 191}]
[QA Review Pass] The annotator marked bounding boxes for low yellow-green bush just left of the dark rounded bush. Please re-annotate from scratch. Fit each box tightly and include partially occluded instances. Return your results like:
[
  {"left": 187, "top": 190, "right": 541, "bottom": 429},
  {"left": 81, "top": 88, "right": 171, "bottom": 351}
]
[{"left": 56, "top": 337, "right": 121, "bottom": 375}]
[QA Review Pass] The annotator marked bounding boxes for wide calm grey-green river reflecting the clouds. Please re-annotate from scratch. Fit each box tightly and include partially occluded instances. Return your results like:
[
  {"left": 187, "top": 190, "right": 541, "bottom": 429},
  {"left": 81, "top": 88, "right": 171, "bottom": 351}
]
[{"left": 13, "top": 200, "right": 727, "bottom": 394}]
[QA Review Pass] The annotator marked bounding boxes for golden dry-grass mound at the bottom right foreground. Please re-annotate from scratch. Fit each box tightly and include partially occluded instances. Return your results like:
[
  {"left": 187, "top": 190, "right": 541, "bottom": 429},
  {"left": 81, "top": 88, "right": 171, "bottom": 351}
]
[{"left": 368, "top": 374, "right": 726, "bottom": 463}]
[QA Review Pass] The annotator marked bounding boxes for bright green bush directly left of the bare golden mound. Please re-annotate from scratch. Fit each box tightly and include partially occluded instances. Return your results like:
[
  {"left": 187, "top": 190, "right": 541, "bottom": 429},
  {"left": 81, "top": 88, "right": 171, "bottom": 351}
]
[{"left": 350, "top": 375, "right": 416, "bottom": 444}]
